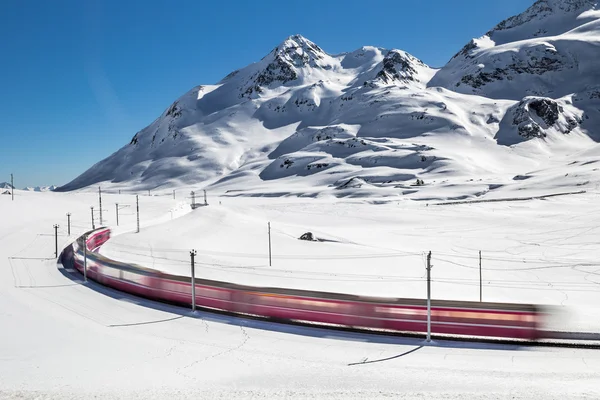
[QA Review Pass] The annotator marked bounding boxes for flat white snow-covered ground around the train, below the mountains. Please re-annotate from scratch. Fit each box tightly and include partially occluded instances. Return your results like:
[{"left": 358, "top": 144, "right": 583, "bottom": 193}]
[{"left": 0, "top": 191, "right": 600, "bottom": 399}]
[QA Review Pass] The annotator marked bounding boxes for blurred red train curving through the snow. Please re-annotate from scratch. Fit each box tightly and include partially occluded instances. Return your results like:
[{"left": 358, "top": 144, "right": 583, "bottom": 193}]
[{"left": 71, "top": 228, "right": 543, "bottom": 340}]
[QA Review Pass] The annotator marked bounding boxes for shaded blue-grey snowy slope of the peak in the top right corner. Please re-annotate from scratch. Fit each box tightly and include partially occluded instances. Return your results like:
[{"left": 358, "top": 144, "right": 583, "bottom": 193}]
[{"left": 429, "top": 0, "right": 600, "bottom": 100}]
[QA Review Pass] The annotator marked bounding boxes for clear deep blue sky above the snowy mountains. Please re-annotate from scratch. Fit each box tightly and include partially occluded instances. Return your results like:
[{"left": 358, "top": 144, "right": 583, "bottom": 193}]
[{"left": 0, "top": 0, "right": 533, "bottom": 188}]
